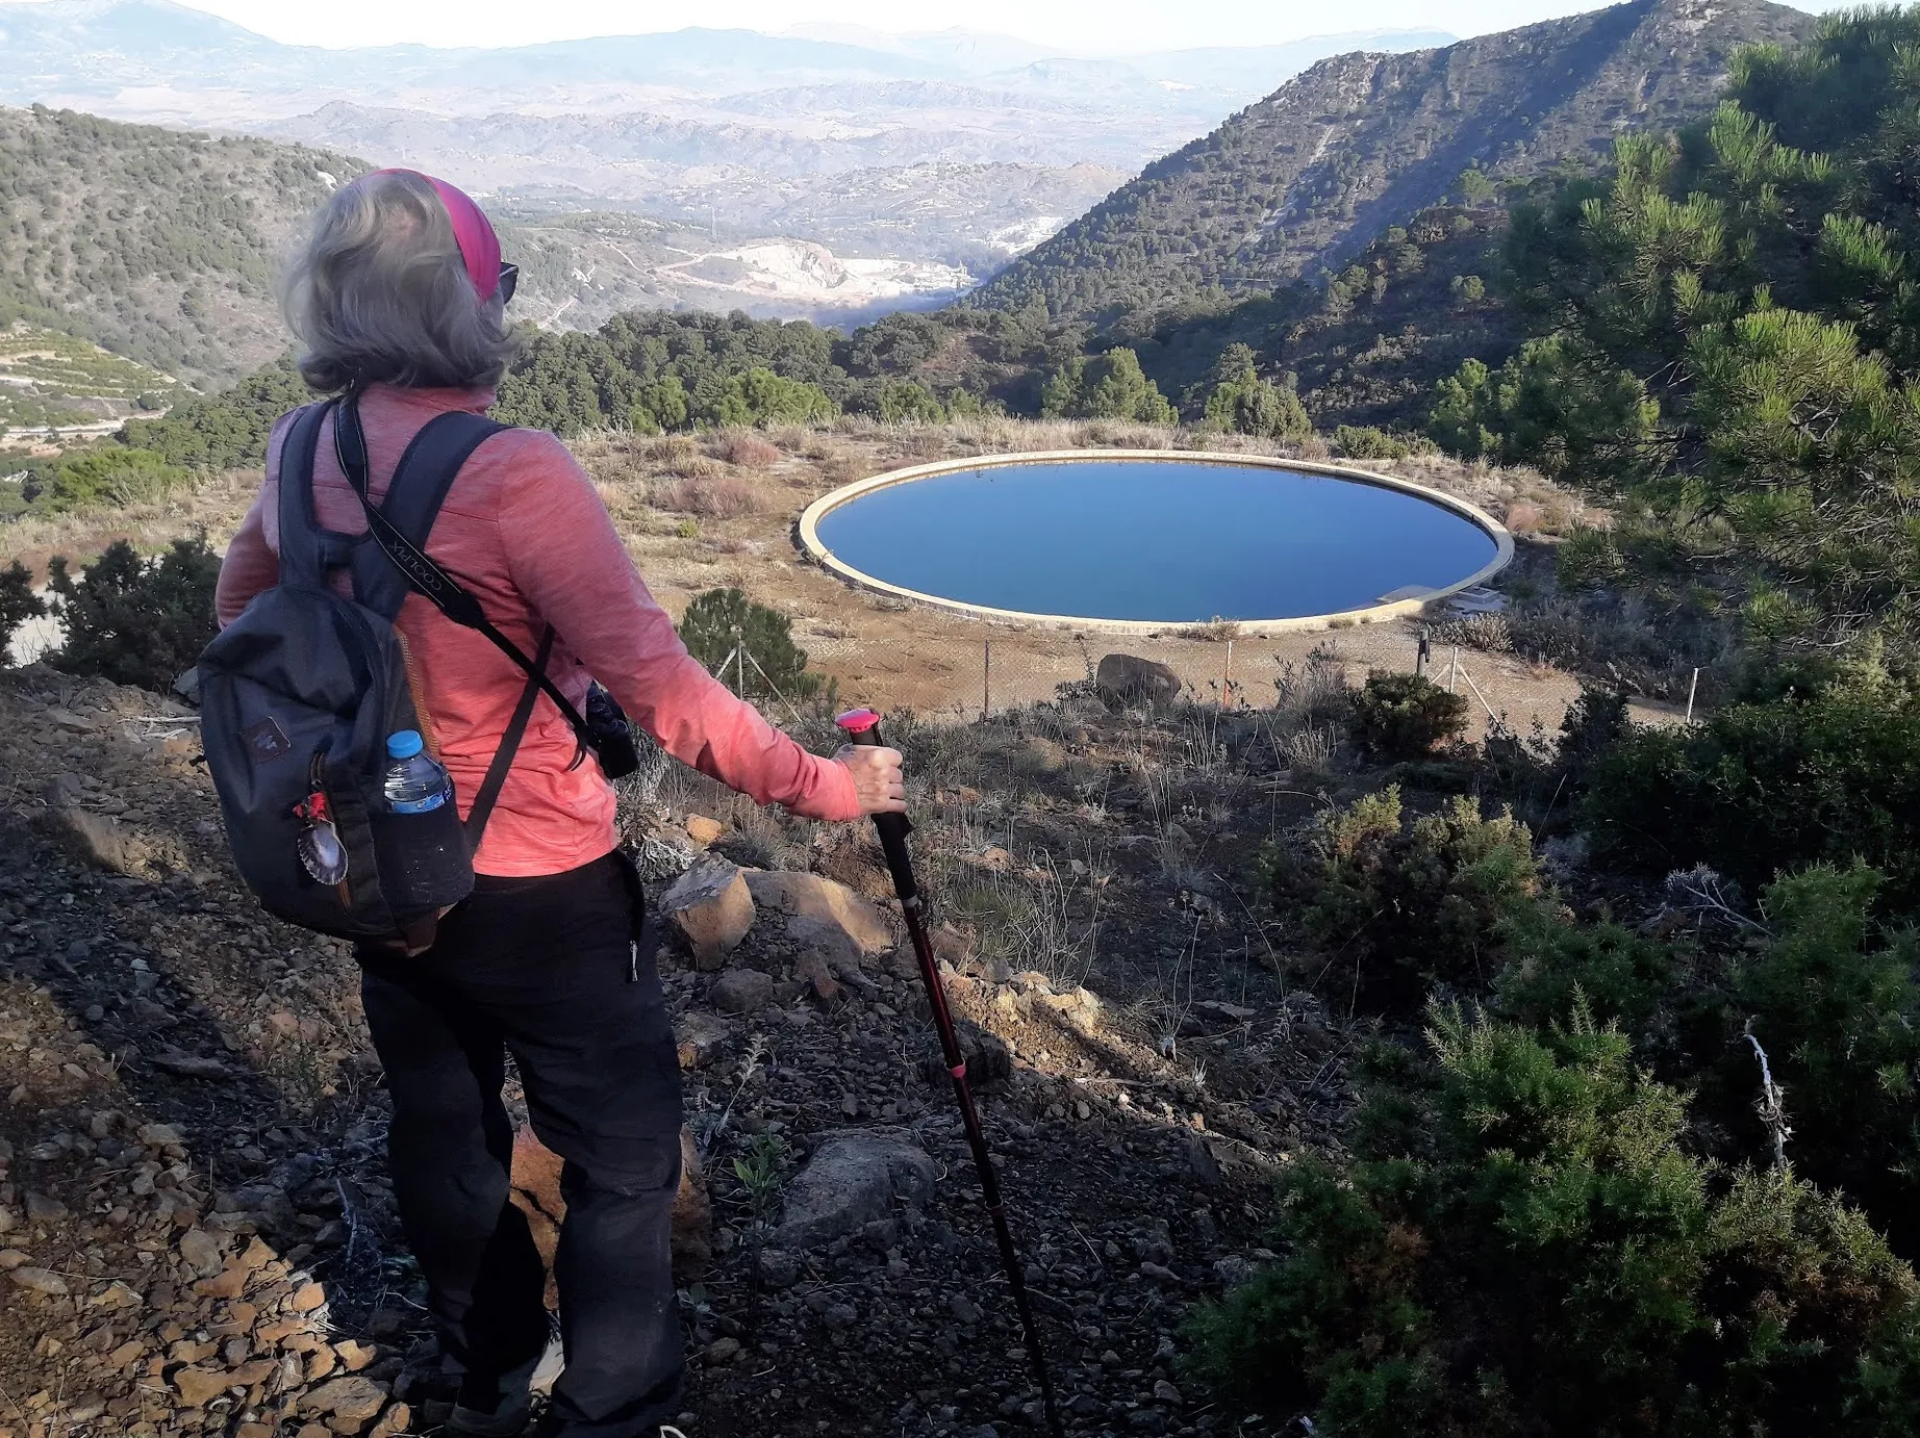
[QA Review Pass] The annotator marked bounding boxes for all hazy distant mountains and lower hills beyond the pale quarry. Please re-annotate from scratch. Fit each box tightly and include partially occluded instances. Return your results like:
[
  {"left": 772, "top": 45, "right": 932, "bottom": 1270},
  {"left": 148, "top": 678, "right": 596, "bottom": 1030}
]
[{"left": 0, "top": 0, "right": 1450, "bottom": 286}]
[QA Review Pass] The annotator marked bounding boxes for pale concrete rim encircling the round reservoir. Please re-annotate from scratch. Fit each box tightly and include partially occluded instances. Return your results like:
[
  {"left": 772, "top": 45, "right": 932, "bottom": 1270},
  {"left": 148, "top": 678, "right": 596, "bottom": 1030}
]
[{"left": 799, "top": 449, "right": 1513, "bottom": 634}]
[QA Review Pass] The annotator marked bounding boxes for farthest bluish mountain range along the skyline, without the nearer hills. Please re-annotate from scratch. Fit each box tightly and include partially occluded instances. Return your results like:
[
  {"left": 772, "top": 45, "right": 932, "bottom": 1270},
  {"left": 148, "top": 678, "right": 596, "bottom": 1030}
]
[{"left": 0, "top": 0, "right": 1452, "bottom": 123}]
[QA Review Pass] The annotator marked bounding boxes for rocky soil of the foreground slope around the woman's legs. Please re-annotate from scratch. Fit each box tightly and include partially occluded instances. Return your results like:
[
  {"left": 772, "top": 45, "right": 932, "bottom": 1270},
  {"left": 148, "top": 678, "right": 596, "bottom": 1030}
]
[{"left": 0, "top": 668, "right": 1352, "bottom": 1438}]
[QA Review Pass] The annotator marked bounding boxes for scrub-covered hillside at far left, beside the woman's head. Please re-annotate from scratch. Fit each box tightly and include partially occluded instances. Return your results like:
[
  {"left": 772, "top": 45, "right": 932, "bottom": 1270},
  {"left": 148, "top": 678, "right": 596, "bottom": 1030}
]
[{"left": 0, "top": 109, "right": 365, "bottom": 380}]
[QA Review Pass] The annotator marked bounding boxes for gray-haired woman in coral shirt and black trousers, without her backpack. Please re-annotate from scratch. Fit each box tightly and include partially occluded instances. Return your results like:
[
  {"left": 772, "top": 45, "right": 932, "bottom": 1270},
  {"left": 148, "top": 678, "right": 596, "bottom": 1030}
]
[{"left": 219, "top": 171, "right": 904, "bottom": 1438}]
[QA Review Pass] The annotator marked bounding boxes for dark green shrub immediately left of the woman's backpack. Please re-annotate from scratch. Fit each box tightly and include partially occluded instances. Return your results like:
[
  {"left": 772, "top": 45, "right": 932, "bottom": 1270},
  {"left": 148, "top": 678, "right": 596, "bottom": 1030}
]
[{"left": 48, "top": 534, "right": 221, "bottom": 691}]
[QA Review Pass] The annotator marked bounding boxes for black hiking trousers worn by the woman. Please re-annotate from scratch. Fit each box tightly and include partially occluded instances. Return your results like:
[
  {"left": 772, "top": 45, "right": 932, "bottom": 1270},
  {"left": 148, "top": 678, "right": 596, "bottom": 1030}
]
[{"left": 359, "top": 854, "right": 684, "bottom": 1438}]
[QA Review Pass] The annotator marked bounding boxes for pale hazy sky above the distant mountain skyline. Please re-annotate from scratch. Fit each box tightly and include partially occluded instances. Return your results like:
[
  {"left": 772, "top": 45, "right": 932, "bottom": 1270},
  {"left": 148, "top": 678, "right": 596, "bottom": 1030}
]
[{"left": 0, "top": 0, "right": 1866, "bottom": 54}]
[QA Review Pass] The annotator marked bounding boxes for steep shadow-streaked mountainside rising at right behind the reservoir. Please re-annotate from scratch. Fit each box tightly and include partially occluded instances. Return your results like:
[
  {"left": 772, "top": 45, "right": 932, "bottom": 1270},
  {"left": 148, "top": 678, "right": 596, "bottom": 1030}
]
[{"left": 968, "top": 0, "right": 1814, "bottom": 319}]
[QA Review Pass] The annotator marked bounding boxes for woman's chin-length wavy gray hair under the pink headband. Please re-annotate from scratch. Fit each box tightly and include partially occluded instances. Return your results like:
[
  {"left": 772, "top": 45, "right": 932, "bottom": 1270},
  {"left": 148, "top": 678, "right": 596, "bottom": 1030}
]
[{"left": 280, "top": 171, "right": 516, "bottom": 392}]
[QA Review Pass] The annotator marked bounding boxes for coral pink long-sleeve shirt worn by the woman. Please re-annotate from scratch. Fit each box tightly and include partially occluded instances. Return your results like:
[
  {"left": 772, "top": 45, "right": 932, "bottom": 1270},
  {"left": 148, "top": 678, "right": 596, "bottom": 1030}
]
[{"left": 217, "top": 384, "right": 860, "bottom": 877}]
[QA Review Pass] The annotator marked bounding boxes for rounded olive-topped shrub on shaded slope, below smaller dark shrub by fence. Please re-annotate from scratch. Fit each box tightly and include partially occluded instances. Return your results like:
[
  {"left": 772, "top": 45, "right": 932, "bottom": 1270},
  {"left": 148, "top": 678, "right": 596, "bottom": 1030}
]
[{"left": 1275, "top": 789, "right": 1540, "bottom": 1008}]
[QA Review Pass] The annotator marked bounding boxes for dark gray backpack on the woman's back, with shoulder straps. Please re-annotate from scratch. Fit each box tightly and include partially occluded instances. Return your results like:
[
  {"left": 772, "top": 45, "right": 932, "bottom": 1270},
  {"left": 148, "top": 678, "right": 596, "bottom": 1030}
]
[{"left": 200, "top": 395, "right": 591, "bottom": 948}]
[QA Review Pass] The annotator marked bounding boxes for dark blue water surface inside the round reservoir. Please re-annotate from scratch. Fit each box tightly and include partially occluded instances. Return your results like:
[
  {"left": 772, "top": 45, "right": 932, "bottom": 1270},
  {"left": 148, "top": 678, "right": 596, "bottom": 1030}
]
[{"left": 820, "top": 459, "right": 1496, "bottom": 622}]
